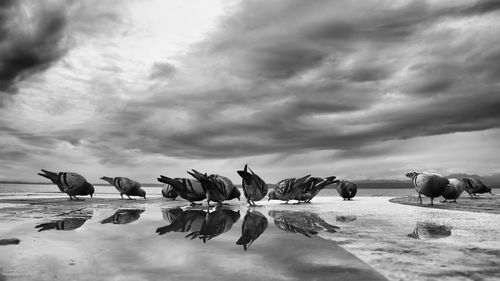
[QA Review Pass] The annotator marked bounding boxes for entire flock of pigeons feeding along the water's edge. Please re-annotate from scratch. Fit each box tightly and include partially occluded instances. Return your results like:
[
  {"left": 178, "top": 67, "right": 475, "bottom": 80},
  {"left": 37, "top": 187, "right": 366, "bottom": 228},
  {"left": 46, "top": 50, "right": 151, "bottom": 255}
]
[{"left": 39, "top": 165, "right": 493, "bottom": 206}]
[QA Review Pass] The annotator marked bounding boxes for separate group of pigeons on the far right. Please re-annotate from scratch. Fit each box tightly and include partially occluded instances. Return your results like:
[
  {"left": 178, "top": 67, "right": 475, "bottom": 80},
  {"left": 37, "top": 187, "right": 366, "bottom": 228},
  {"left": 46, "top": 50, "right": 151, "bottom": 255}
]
[{"left": 405, "top": 172, "right": 493, "bottom": 205}]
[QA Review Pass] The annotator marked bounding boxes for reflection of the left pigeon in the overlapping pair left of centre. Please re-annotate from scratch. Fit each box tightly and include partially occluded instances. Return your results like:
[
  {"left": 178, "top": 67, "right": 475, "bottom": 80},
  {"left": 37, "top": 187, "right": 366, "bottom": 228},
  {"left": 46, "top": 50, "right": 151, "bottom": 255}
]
[{"left": 156, "top": 208, "right": 207, "bottom": 235}]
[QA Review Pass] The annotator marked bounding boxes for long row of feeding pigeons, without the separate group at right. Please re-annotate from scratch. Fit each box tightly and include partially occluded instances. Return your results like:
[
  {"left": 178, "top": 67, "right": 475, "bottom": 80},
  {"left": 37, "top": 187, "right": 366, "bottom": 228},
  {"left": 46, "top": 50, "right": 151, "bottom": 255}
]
[{"left": 39, "top": 165, "right": 357, "bottom": 206}]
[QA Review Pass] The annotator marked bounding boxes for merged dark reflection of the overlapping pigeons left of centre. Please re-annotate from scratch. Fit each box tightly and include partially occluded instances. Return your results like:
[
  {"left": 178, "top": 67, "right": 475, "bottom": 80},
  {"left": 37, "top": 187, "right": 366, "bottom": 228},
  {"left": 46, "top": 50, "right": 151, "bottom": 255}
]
[{"left": 156, "top": 207, "right": 240, "bottom": 243}]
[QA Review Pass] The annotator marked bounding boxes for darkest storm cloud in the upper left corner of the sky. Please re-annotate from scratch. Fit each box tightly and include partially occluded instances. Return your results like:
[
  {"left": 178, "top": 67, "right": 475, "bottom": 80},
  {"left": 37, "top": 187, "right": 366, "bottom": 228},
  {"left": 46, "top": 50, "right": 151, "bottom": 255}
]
[{"left": 0, "top": 1, "right": 67, "bottom": 93}]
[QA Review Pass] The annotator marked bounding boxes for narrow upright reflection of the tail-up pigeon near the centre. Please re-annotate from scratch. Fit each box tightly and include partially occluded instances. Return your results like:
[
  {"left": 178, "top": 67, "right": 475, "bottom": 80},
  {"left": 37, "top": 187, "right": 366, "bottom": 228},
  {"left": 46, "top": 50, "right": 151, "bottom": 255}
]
[{"left": 236, "top": 209, "right": 267, "bottom": 251}]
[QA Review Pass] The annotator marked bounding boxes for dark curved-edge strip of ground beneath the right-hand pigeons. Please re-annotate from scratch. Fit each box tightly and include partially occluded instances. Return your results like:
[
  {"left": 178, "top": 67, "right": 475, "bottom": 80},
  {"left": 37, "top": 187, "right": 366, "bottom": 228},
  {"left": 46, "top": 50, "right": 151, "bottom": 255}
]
[{"left": 390, "top": 194, "right": 500, "bottom": 214}]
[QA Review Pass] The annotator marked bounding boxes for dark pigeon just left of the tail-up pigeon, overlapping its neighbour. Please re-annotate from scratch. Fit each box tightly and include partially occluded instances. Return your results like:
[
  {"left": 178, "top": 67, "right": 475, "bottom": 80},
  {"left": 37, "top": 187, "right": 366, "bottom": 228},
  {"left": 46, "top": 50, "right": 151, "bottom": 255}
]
[{"left": 187, "top": 169, "right": 241, "bottom": 206}]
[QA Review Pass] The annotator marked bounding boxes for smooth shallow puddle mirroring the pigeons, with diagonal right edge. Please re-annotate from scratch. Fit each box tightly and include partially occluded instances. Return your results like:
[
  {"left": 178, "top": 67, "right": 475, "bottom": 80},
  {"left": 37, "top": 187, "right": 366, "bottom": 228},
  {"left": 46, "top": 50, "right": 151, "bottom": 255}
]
[{"left": 0, "top": 202, "right": 385, "bottom": 280}]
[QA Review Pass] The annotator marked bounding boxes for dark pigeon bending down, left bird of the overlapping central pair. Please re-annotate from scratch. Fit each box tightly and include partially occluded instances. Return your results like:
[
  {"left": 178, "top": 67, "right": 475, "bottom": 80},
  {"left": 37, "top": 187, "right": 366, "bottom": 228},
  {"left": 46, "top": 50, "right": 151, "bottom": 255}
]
[{"left": 158, "top": 175, "right": 207, "bottom": 205}]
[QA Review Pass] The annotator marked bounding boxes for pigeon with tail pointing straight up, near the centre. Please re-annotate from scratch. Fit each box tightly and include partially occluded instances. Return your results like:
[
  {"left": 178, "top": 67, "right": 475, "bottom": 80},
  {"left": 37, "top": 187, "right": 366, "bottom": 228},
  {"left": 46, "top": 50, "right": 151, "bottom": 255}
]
[{"left": 237, "top": 165, "right": 269, "bottom": 206}]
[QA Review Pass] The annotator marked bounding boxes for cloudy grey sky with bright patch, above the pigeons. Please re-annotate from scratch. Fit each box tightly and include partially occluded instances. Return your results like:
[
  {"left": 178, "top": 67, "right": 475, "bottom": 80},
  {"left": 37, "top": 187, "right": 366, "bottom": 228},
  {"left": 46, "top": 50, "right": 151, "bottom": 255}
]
[{"left": 0, "top": 0, "right": 500, "bottom": 182}]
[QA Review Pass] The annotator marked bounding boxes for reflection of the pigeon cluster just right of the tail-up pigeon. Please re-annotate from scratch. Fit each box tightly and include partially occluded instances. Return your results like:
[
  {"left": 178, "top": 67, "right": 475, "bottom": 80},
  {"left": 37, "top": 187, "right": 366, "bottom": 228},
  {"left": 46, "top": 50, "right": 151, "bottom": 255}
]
[{"left": 269, "top": 210, "right": 339, "bottom": 237}]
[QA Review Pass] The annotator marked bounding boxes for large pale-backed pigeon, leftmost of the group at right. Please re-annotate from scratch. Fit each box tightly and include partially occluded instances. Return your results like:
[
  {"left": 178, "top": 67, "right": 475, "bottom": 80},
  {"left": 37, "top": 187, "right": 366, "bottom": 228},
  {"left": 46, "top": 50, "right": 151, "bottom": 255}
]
[{"left": 405, "top": 172, "right": 449, "bottom": 205}]
